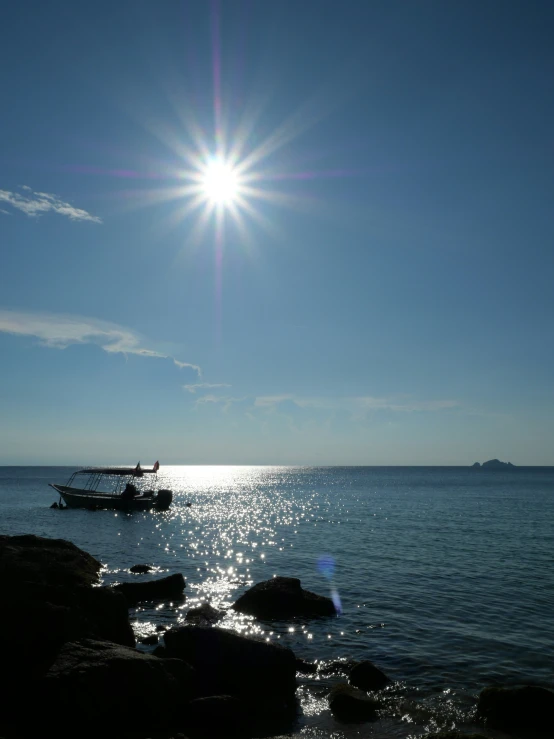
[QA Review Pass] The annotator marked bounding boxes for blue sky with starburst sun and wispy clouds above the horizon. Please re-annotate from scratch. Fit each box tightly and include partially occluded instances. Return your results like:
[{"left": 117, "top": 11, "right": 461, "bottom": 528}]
[{"left": 0, "top": 0, "right": 554, "bottom": 465}]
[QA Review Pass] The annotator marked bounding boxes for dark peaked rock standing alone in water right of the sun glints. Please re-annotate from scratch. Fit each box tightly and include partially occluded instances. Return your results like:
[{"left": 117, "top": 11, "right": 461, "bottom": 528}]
[{"left": 233, "top": 577, "right": 336, "bottom": 620}]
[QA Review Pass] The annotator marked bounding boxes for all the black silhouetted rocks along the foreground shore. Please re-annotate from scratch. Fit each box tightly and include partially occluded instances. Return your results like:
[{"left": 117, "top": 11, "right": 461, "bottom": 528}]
[{"left": 0, "top": 535, "right": 554, "bottom": 739}]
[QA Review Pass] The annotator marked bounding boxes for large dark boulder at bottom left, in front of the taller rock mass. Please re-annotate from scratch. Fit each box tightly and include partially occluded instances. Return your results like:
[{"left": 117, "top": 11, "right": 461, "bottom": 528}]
[{"left": 37, "top": 639, "right": 194, "bottom": 735}]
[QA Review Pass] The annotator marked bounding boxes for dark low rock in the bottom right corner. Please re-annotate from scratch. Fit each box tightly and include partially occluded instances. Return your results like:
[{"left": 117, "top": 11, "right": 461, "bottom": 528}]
[{"left": 477, "top": 685, "right": 554, "bottom": 730}]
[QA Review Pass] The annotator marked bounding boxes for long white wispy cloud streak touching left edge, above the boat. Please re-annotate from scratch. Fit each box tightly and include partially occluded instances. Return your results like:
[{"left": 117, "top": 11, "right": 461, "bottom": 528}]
[{"left": 0, "top": 310, "right": 198, "bottom": 377}]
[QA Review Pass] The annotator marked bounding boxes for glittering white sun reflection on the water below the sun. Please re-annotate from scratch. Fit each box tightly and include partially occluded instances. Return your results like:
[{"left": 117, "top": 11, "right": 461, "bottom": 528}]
[{"left": 110, "top": 466, "right": 338, "bottom": 645}]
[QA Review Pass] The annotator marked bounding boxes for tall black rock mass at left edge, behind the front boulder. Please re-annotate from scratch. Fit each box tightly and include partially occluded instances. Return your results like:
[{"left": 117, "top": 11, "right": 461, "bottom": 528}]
[{"left": 0, "top": 536, "right": 135, "bottom": 692}]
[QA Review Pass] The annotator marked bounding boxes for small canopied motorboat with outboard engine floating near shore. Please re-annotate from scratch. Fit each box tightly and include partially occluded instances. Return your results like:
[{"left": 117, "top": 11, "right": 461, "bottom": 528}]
[{"left": 48, "top": 462, "right": 173, "bottom": 511}]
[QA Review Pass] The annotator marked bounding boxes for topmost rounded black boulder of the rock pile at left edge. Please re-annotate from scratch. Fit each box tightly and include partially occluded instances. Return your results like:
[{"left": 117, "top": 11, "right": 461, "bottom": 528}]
[{"left": 0, "top": 534, "right": 102, "bottom": 588}]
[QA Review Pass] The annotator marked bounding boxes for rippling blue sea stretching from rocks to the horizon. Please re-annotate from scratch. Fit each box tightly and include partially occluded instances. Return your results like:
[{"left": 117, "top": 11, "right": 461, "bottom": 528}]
[{"left": 0, "top": 466, "right": 554, "bottom": 739}]
